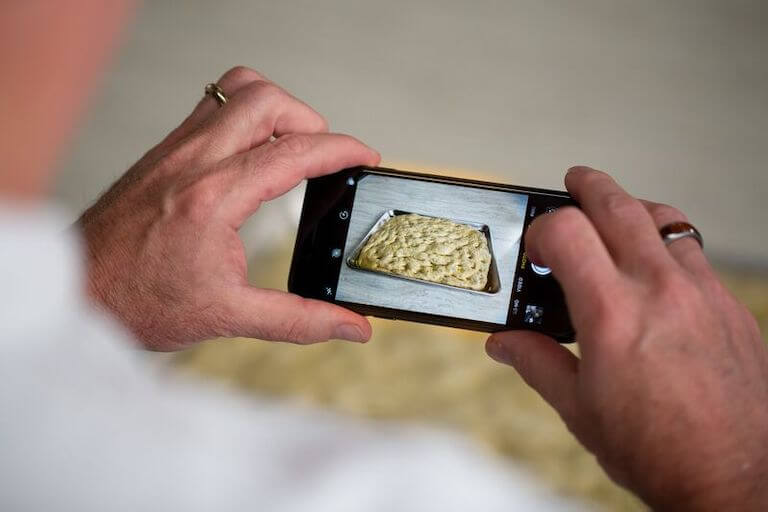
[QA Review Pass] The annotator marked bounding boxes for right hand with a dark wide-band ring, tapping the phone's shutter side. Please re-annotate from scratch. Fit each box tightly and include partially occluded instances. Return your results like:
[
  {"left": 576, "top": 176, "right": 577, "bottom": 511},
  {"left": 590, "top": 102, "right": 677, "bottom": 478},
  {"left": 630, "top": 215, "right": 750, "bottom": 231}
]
[{"left": 486, "top": 167, "right": 768, "bottom": 511}]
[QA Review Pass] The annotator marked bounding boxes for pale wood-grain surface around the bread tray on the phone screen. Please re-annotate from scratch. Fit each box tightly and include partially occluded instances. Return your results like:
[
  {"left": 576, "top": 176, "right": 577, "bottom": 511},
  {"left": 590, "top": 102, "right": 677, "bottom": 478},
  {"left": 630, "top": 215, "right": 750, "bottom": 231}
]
[{"left": 336, "top": 175, "right": 527, "bottom": 323}]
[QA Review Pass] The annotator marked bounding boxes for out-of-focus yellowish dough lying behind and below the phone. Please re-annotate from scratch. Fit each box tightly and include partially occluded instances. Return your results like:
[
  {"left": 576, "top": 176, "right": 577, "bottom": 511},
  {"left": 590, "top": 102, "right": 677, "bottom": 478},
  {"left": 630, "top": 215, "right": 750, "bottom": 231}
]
[{"left": 174, "top": 206, "right": 768, "bottom": 511}]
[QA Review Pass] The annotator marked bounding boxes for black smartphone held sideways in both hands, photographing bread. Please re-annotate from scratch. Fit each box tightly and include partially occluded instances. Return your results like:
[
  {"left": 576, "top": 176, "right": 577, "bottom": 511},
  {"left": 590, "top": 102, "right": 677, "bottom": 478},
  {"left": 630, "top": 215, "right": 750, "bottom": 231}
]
[{"left": 288, "top": 167, "right": 576, "bottom": 342}]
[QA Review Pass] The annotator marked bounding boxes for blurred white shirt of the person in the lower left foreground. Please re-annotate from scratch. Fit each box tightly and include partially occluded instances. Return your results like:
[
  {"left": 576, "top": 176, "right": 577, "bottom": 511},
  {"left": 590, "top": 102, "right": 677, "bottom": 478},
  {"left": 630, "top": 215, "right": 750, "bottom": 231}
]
[{"left": 0, "top": 205, "right": 580, "bottom": 512}]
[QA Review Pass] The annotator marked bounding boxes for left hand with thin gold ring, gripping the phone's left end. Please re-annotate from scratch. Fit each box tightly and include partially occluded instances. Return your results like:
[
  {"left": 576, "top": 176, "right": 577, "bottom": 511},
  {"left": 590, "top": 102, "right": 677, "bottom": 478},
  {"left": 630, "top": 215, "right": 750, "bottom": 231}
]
[{"left": 80, "top": 68, "right": 379, "bottom": 350}]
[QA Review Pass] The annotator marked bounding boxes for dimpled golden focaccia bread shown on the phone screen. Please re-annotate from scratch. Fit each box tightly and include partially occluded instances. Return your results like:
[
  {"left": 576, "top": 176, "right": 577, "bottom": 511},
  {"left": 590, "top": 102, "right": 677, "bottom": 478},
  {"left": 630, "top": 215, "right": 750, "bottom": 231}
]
[{"left": 357, "top": 214, "right": 491, "bottom": 290}]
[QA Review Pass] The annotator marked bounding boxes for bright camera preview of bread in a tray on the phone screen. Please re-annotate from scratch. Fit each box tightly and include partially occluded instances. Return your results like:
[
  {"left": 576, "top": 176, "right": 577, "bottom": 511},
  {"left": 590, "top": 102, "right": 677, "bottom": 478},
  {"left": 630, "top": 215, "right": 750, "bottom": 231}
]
[{"left": 335, "top": 174, "right": 528, "bottom": 324}]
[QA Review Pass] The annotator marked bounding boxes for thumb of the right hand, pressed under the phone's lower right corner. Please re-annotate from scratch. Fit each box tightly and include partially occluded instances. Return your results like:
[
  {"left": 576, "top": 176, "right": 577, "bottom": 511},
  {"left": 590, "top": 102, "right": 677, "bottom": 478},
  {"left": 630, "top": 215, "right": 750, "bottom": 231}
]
[{"left": 485, "top": 331, "right": 579, "bottom": 417}]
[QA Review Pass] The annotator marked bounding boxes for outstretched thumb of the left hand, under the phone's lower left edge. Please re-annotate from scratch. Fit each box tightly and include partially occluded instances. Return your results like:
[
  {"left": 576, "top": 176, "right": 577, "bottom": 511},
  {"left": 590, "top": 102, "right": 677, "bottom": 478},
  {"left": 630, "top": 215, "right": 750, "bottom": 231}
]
[{"left": 228, "top": 287, "right": 371, "bottom": 344}]
